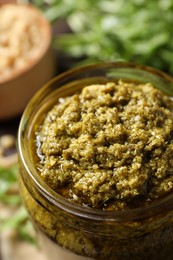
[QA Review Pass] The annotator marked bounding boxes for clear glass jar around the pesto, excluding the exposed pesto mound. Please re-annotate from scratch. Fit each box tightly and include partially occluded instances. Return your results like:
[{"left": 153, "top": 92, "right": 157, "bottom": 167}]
[{"left": 18, "top": 62, "right": 173, "bottom": 260}]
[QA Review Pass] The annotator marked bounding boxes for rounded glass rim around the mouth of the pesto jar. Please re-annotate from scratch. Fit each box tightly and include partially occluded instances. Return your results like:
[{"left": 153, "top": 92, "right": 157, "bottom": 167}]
[{"left": 18, "top": 62, "right": 173, "bottom": 222}]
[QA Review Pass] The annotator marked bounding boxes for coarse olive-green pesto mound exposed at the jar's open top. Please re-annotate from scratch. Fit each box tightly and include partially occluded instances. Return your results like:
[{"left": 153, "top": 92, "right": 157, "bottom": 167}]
[{"left": 36, "top": 80, "right": 173, "bottom": 210}]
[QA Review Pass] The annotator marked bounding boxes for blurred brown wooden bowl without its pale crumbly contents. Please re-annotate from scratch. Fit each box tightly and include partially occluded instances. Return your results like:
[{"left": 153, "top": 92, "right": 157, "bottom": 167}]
[{"left": 0, "top": 4, "right": 55, "bottom": 120}]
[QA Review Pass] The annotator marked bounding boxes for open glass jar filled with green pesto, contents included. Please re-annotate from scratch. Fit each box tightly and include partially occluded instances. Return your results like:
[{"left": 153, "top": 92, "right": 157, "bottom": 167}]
[{"left": 18, "top": 62, "right": 173, "bottom": 260}]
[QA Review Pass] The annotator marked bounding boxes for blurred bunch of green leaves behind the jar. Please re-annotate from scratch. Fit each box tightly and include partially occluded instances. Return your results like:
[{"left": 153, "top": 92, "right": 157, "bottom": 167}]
[{"left": 32, "top": 0, "right": 173, "bottom": 74}]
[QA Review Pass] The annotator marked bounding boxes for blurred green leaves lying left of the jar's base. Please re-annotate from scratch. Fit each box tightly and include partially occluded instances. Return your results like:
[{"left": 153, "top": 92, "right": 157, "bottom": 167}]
[{"left": 0, "top": 166, "right": 35, "bottom": 243}]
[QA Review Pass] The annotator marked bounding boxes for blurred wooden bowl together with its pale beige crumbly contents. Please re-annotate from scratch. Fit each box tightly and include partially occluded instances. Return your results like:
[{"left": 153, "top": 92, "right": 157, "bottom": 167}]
[{"left": 0, "top": 3, "right": 54, "bottom": 120}]
